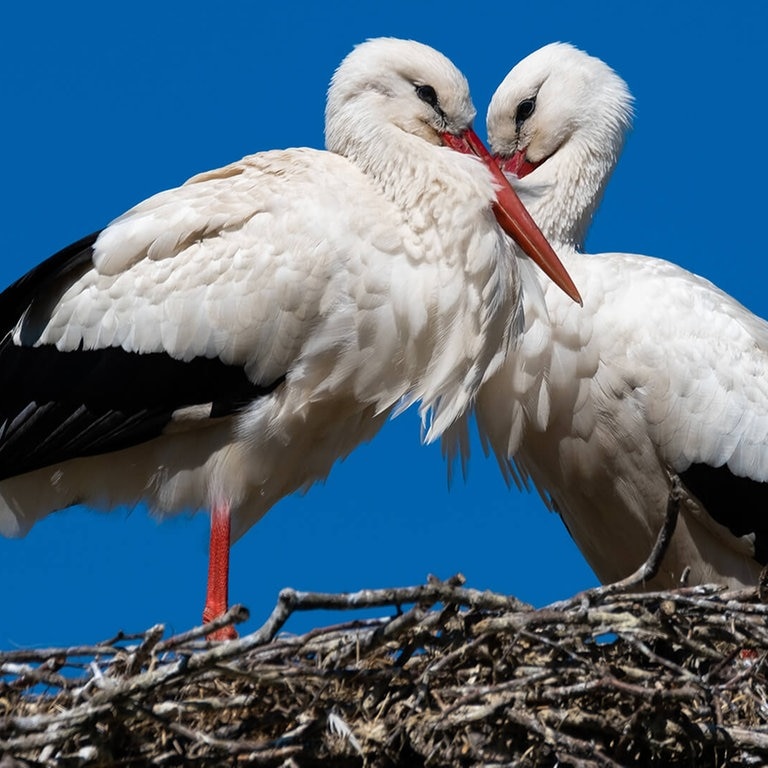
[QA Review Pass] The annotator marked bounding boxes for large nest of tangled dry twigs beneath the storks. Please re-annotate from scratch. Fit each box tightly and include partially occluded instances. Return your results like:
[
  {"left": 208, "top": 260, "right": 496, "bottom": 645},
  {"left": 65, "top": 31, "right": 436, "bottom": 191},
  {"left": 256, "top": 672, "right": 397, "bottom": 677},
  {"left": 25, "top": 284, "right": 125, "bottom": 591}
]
[{"left": 0, "top": 488, "right": 768, "bottom": 768}]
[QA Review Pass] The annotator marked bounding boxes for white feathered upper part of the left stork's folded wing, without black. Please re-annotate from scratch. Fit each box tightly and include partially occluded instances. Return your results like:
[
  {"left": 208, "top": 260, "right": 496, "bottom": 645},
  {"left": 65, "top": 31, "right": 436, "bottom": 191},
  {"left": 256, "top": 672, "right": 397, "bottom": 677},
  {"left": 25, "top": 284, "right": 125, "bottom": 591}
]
[{"left": 17, "top": 149, "right": 402, "bottom": 388}]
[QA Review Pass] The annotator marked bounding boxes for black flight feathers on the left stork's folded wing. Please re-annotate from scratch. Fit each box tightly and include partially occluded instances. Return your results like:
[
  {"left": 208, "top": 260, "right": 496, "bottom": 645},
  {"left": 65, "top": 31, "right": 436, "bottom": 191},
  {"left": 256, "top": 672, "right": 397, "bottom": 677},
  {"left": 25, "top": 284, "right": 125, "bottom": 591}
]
[{"left": 0, "top": 233, "right": 285, "bottom": 479}]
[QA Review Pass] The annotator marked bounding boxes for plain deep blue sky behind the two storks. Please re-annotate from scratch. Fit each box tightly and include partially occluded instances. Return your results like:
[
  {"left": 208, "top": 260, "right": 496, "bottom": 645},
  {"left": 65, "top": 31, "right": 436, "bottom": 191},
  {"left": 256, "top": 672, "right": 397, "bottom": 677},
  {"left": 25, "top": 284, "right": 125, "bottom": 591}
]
[{"left": 0, "top": 0, "right": 768, "bottom": 648}]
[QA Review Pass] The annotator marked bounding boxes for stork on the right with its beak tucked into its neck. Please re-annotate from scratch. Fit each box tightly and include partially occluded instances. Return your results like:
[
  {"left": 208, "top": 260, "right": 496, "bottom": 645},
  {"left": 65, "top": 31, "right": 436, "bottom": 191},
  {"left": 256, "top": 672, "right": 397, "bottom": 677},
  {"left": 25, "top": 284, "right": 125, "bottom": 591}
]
[{"left": 456, "top": 44, "right": 768, "bottom": 588}]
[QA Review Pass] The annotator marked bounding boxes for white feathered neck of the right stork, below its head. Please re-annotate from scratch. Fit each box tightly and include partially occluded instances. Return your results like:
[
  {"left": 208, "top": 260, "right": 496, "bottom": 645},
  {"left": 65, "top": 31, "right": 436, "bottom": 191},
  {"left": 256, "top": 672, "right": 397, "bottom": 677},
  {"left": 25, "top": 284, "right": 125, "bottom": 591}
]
[{"left": 515, "top": 131, "right": 623, "bottom": 250}]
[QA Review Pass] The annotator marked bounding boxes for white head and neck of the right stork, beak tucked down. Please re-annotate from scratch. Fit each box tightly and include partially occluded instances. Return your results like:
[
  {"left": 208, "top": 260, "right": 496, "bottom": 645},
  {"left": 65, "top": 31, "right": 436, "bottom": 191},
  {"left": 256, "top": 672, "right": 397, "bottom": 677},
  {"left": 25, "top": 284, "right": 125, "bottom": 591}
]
[{"left": 487, "top": 43, "right": 632, "bottom": 247}]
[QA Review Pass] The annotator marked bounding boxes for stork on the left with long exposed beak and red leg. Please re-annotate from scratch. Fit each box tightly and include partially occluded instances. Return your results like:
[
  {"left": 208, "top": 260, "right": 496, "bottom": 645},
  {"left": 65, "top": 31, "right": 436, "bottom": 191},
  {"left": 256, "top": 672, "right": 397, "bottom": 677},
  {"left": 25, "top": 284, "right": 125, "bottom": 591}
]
[{"left": 0, "top": 39, "right": 577, "bottom": 637}]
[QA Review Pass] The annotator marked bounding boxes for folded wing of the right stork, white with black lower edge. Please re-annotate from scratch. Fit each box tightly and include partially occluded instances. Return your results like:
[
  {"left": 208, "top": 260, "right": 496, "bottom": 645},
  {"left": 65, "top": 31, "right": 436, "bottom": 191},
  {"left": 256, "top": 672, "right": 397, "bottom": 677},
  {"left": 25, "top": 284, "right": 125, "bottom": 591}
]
[{"left": 600, "top": 256, "right": 768, "bottom": 563}]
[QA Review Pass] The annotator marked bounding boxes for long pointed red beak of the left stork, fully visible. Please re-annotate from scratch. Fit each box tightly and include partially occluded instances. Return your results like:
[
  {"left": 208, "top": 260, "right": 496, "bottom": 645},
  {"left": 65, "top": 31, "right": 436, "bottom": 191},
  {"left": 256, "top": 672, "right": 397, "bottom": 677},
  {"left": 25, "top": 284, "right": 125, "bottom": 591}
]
[{"left": 442, "top": 128, "right": 583, "bottom": 304}]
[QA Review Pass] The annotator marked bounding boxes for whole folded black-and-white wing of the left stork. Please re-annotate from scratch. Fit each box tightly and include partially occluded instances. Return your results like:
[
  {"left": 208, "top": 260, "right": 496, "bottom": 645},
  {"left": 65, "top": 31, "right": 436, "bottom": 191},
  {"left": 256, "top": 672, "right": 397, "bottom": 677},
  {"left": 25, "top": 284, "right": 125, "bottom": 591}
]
[{"left": 0, "top": 150, "right": 390, "bottom": 478}]
